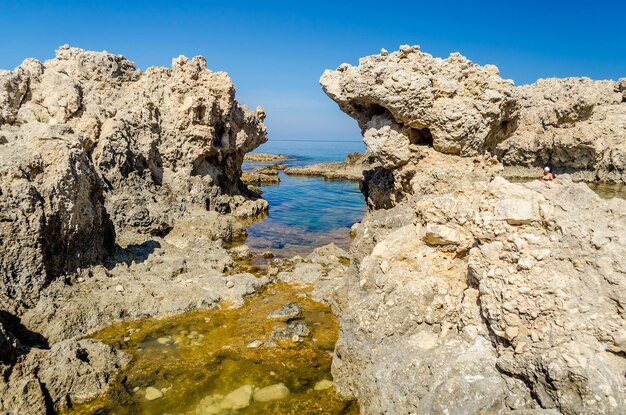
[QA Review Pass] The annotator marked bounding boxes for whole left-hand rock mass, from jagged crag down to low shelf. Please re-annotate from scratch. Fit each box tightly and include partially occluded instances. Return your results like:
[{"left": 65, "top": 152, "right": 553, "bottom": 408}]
[{"left": 0, "top": 46, "right": 267, "bottom": 414}]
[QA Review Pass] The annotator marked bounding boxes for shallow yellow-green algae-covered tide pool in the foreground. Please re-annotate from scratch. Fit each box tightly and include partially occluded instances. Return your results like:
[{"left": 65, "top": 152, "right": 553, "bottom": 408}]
[{"left": 67, "top": 284, "right": 359, "bottom": 415}]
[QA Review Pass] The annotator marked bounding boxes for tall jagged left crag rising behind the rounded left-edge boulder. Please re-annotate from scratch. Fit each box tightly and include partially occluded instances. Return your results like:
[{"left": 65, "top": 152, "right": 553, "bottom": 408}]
[{"left": 0, "top": 46, "right": 266, "bottom": 233}]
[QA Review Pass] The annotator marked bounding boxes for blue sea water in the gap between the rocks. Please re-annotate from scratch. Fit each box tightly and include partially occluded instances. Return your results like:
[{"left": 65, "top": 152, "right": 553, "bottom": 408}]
[{"left": 243, "top": 140, "right": 365, "bottom": 256}]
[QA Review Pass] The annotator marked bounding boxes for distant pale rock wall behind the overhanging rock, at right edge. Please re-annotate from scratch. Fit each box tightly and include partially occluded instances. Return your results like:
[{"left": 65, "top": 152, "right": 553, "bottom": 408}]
[{"left": 496, "top": 78, "right": 626, "bottom": 182}]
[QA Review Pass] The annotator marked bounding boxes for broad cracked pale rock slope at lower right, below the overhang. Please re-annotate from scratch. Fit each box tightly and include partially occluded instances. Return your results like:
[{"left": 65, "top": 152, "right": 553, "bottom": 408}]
[{"left": 333, "top": 178, "right": 626, "bottom": 414}]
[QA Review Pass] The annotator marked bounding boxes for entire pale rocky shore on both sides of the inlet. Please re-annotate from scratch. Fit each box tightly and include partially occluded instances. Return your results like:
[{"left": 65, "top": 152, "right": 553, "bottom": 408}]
[{"left": 0, "top": 46, "right": 626, "bottom": 414}]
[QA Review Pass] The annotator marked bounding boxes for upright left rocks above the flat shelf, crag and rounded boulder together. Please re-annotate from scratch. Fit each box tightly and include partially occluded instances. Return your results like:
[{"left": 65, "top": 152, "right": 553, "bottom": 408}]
[{"left": 0, "top": 46, "right": 267, "bottom": 307}]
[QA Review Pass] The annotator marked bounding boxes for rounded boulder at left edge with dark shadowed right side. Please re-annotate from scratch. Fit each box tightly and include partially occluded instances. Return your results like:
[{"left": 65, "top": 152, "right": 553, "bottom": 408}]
[{"left": 0, "top": 122, "right": 114, "bottom": 311}]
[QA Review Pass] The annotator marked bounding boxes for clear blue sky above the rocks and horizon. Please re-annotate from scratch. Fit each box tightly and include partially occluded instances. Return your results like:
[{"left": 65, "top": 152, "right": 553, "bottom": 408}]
[{"left": 0, "top": 0, "right": 626, "bottom": 140}]
